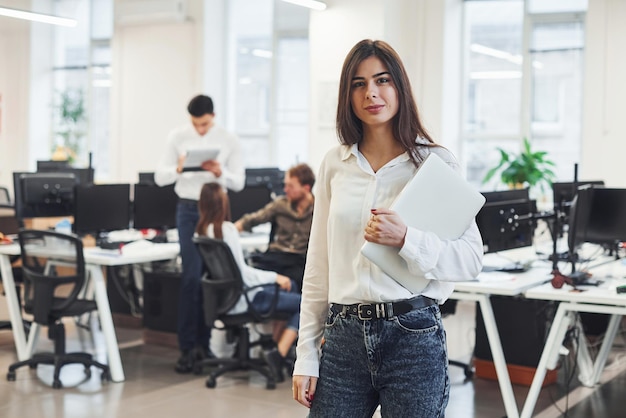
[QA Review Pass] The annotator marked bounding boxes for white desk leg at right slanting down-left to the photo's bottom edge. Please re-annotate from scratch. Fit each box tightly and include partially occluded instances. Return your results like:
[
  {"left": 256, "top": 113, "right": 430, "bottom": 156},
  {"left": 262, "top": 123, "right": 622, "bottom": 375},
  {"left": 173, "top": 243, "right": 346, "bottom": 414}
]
[{"left": 521, "top": 303, "right": 571, "bottom": 418}]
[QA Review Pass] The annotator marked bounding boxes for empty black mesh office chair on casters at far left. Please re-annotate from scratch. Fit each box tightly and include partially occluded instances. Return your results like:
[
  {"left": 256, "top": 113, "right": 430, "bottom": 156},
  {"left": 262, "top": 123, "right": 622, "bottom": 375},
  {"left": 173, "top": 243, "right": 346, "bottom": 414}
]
[{"left": 7, "top": 229, "right": 111, "bottom": 389}]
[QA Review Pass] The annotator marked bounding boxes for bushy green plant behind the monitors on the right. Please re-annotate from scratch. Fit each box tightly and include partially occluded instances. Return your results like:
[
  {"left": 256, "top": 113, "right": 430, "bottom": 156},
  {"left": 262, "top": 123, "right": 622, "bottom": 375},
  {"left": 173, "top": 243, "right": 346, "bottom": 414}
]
[{"left": 483, "top": 138, "right": 555, "bottom": 191}]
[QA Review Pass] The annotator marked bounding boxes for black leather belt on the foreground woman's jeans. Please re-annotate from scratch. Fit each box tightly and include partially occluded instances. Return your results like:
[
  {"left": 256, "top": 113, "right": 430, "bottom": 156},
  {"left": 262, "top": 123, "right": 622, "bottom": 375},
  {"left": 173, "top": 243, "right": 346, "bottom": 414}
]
[{"left": 330, "top": 295, "right": 437, "bottom": 321}]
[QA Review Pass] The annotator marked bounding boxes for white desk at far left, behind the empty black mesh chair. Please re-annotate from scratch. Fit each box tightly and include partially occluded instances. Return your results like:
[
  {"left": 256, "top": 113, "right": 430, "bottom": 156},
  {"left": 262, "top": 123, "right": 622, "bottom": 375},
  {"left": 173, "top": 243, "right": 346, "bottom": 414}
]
[{"left": 0, "top": 243, "right": 180, "bottom": 382}]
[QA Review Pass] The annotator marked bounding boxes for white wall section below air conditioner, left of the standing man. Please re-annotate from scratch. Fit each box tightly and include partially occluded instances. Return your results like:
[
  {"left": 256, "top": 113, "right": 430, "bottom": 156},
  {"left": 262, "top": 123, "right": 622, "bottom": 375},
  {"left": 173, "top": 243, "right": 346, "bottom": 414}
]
[{"left": 110, "top": 0, "right": 203, "bottom": 182}]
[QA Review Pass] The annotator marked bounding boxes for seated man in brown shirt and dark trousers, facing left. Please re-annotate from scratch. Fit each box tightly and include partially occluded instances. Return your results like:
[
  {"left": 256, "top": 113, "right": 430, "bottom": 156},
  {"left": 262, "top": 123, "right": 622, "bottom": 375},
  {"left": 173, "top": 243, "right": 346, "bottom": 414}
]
[{"left": 235, "top": 164, "right": 315, "bottom": 291}]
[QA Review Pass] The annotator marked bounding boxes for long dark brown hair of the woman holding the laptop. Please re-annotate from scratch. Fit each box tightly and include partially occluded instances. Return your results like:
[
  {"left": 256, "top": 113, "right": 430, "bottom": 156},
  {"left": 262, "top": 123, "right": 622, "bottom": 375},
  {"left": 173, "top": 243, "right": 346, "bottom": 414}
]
[{"left": 337, "top": 39, "right": 436, "bottom": 166}]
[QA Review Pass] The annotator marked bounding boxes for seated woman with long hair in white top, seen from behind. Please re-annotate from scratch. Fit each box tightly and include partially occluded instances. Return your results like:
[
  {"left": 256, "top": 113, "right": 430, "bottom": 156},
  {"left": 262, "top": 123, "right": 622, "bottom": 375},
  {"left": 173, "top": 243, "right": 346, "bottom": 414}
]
[{"left": 196, "top": 183, "right": 301, "bottom": 382}]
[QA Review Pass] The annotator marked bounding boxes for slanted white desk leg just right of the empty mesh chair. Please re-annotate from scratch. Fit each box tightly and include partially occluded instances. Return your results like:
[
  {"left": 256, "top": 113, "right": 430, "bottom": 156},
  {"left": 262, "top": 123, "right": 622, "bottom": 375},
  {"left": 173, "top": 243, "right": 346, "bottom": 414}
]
[{"left": 87, "top": 264, "right": 124, "bottom": 382}]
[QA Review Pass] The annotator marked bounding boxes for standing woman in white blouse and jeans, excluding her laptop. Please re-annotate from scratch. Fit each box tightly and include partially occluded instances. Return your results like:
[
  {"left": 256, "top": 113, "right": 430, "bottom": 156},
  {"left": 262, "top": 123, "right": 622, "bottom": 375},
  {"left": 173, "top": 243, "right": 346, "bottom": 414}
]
[{"left": 293, "top": 40, "right": 483, "bottom": 418}]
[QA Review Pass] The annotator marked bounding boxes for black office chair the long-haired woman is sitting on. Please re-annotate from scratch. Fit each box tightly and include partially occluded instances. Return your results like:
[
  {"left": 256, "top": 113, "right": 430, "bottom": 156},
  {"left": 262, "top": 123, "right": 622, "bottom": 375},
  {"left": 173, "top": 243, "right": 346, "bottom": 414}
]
[{"left": 194, "top": 237, "right": 286, "bottom": 389}]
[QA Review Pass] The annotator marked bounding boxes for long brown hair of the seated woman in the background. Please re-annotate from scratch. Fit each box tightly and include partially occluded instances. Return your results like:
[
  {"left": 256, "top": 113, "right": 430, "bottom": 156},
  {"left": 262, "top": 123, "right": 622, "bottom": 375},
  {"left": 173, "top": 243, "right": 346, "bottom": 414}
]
[{"left": 196, "top": 183, "right": 230, "bottom": 239}]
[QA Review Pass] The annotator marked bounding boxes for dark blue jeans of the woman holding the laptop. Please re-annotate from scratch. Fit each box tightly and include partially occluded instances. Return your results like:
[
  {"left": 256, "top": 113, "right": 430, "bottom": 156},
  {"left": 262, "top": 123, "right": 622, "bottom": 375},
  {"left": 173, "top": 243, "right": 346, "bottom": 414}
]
[{"left": 309, "top": 305, "right": 450, "bottom": 418}]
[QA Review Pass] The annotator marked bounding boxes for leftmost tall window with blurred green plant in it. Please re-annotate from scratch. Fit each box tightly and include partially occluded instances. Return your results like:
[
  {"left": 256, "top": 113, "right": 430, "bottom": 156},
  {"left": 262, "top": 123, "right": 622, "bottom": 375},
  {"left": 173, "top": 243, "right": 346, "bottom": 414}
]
[{"left": 51, "top": 0, "right": 113, "bottom": 178}]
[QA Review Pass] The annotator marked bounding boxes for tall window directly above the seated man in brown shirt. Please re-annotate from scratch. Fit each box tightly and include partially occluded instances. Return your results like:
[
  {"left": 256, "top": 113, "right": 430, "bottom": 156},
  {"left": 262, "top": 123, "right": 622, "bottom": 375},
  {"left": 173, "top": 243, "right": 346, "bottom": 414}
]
[{"left": 227, "top": 0, "right": 309, "bottom": 169}]
